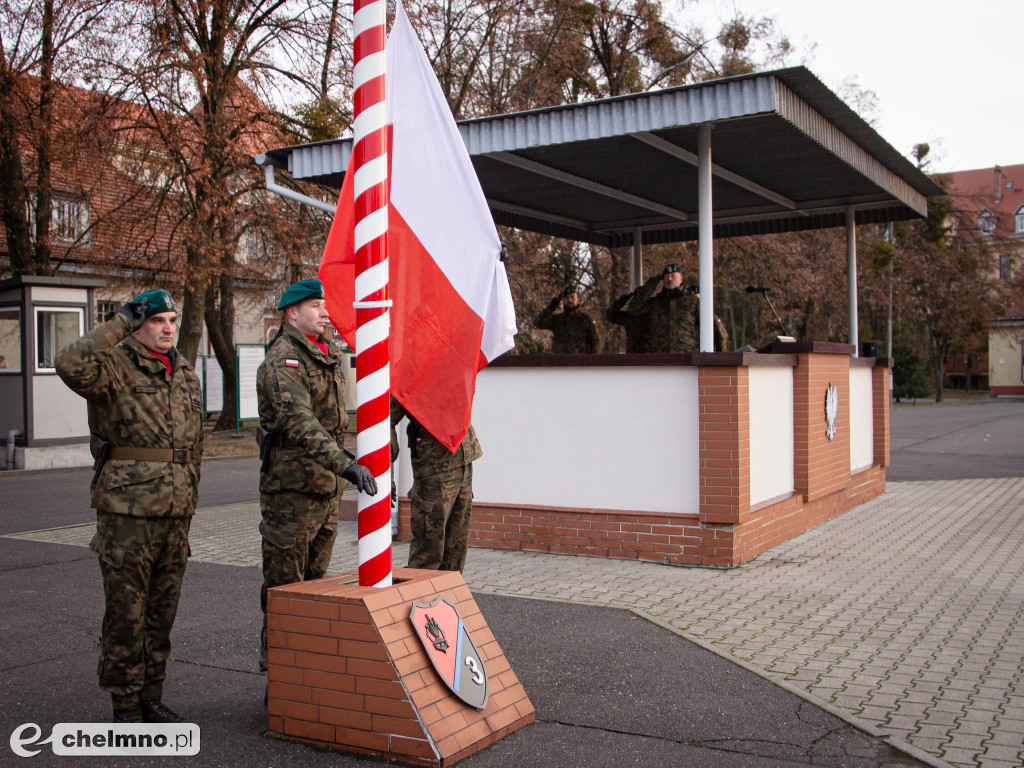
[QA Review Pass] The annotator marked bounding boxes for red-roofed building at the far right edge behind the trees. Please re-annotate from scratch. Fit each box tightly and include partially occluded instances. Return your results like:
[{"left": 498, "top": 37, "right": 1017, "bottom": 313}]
[{"left": 948, "top": 165, "right": 1024, "bottom": 397}]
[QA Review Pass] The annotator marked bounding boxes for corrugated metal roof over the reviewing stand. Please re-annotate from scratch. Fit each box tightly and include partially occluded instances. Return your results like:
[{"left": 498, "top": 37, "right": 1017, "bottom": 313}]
[{"left": 256, "top": 67, "right": 942, "bottom": 246}]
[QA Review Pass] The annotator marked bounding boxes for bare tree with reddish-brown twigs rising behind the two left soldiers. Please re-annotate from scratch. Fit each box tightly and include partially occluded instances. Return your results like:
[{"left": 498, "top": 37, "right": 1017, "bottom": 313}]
[{"left": 100, "top": 0, "right": 348, "bottom": 429}]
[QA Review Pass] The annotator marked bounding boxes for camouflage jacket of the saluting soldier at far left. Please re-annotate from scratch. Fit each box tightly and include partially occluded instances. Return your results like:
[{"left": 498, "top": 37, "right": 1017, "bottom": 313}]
[{"left": 56, "top": 314, "right": 204, "bottom": 517}]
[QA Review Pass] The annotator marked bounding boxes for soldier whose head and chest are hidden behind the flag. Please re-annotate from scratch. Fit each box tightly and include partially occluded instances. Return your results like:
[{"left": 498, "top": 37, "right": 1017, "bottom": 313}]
[{"left": 391, "top": 397, "right": 483, "bottom": 571}]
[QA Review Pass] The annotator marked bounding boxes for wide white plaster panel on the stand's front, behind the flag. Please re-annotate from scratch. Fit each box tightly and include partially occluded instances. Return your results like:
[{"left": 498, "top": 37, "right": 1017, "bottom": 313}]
[{"left": 444, "top": 367, "right": 699, "bottom": 514}]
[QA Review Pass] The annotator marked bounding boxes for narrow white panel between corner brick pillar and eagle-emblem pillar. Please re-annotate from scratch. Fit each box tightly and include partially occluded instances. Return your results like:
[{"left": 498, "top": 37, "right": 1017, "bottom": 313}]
[{"left": 749, "top": 366, "right": 795, "bottom": 506}]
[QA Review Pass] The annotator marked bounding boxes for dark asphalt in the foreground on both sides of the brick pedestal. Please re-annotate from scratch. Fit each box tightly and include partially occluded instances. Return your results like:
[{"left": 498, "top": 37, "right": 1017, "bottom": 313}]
[{"left": 0, "top": 539, "right": 921, "bottom": 768}]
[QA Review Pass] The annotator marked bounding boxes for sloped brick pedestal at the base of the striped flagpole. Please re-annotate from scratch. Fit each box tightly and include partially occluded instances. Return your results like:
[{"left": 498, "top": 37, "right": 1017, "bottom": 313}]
[{"left": 267, "top": 568, "right": 535, "bottom": 766}]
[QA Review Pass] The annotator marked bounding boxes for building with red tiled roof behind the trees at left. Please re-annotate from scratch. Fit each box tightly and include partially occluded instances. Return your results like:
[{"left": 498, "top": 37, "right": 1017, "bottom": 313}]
[{"left": 0, "top": 78, "right": 309, "bottom": 411}]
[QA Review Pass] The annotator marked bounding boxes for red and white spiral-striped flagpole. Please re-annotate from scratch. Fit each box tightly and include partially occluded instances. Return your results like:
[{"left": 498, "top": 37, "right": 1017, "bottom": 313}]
[{"left": 351, "top": 0, "right": 391, "bottom": 587}]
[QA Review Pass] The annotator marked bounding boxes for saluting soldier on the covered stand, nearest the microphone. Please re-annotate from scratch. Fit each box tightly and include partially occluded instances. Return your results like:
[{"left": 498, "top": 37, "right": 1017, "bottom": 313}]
[{"left": 630, "top": 264, "right": 728, "bottom": 352}]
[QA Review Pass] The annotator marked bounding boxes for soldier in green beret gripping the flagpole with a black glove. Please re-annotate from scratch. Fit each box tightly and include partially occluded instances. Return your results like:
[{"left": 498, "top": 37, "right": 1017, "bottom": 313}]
[{"left": 256, "top": 280, "right": 377, "bottom": 671}]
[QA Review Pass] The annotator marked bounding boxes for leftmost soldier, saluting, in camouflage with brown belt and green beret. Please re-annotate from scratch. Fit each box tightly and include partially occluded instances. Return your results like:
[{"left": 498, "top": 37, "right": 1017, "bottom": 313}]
[{"left": 56, "top": 290, "right": 203, "bottom": 723}]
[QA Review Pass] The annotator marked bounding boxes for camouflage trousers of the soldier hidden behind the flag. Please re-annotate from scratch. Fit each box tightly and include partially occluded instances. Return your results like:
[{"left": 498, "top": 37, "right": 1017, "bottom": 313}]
[{"left": 409, "top": 464, "right": 473, "bottom": 571}]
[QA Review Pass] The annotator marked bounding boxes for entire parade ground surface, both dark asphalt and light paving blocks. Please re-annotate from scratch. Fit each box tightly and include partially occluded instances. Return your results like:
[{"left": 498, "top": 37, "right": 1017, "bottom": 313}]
[{"left": 0, "top": 401, "right": 1024, "bottom": 768}]
